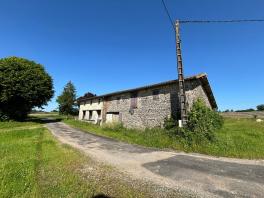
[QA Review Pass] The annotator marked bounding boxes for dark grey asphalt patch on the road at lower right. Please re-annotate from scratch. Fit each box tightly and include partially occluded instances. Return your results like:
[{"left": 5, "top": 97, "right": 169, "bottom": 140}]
[{"left": 143, "top": 155, "right": 264, "bottom": 184}]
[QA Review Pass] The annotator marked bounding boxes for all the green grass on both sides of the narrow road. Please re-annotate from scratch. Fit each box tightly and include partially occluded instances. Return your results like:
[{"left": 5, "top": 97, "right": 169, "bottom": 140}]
[{"left": 0, "top": 116, "right": 264, "bottom": 197}]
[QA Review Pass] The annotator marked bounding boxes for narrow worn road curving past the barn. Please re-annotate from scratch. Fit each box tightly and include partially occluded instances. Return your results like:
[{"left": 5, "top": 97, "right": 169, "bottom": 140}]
[{"left": 46, "top": 122, "right": 264, "bottom": 197}]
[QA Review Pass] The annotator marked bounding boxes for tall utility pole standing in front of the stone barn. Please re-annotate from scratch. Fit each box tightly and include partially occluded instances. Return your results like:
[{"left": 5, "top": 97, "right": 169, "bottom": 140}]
[{"left": 175, "top": 20, "right": 187, "bottom": 127}]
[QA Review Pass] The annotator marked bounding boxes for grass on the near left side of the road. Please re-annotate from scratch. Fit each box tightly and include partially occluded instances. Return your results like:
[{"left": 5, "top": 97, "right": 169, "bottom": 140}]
[{"left": 0, "top": 122, "right": 153, "bottom": 197}]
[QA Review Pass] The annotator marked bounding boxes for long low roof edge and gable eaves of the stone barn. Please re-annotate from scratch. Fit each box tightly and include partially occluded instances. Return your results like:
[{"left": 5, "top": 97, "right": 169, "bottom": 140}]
[{"left": 77, "top": 73, "right": 217, "bottom": 108}]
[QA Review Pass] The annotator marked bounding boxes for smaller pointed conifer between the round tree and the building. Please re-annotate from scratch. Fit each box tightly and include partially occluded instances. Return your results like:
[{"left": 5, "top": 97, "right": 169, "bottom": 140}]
[{"left": 57, "top": 81, "right": 78, "bottom": 115}]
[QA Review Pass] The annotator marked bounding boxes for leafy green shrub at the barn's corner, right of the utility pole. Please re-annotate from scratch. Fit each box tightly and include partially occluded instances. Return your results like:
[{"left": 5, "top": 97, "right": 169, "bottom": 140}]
[{"left": 186, "top": 99, "right": 224, "bottom": 141}]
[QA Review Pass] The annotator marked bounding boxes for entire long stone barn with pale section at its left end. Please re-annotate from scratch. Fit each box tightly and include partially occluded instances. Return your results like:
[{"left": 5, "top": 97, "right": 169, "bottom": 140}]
[{"left": 78, "top": 74, "right": 217, "bottom": 128}]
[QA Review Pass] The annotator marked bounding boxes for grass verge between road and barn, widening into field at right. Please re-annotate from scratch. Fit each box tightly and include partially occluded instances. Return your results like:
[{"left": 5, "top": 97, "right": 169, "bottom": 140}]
[{"left": 63, "top": 118, "right": 264, "bottom": 159}]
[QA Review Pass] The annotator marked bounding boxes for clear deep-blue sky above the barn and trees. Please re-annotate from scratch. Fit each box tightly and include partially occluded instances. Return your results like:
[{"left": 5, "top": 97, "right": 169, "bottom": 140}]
[{"left": 0, "top": 0, "right": 264, "bottom": 111}]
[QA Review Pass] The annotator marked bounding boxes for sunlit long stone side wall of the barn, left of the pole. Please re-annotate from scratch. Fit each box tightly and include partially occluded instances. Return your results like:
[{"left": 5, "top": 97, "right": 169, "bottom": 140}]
[{"left": 105, "top": 86, "right": 171, "bottom": 128}]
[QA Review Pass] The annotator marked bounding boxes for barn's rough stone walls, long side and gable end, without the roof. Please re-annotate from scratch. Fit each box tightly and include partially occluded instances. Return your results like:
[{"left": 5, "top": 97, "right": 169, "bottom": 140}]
[{"left": 103, "top": 79, "right": 211, "bottom": 128}]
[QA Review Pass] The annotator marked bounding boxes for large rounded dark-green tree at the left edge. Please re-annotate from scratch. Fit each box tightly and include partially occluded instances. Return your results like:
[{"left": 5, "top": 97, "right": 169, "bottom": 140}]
[{"left": 0, "top": 57, "right": 54, "bottom": 120}]
